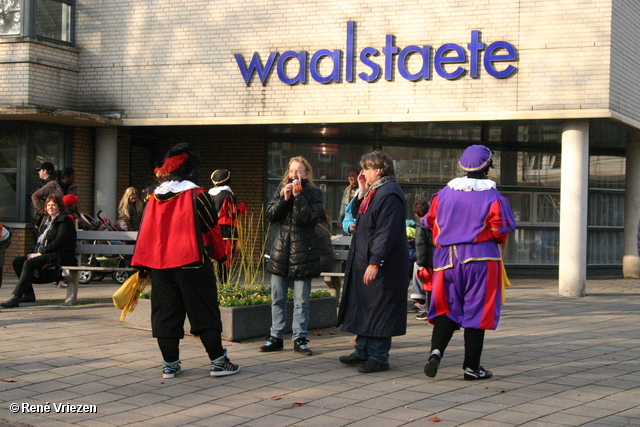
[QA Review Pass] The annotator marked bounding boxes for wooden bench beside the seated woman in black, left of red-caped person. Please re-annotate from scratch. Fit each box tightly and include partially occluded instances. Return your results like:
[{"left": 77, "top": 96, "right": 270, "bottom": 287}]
[{"left": 62, "top": 230, "right": 138, "bottom": 305}]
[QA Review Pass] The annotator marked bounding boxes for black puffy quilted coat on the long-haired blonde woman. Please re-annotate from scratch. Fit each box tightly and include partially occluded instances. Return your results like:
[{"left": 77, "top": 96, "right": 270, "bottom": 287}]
[{"left": 266, "top": 183, "right": 324, "bottom": 280}]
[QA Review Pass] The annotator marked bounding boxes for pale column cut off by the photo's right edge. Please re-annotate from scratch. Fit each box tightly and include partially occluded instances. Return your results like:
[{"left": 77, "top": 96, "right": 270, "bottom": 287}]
[{"left": 622, "top": 130, "right": 640, "bottom": 279}]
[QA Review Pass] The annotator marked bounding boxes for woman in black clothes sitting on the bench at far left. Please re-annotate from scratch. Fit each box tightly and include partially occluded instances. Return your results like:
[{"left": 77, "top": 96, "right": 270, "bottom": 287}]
[{"left": 0, "top": 194, "right": 76, "bottom": 308}]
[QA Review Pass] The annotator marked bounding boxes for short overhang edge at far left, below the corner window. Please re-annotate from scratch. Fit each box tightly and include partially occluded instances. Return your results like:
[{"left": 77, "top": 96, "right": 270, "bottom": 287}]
[{"left": 0, "top": 105, "right": 122, "bottom": 127}]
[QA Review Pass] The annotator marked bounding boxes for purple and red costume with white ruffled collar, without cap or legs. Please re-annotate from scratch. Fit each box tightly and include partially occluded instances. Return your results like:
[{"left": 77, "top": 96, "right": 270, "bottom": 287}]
[{"left": 423, "top": 178, "right": 516, "bottom": 329}]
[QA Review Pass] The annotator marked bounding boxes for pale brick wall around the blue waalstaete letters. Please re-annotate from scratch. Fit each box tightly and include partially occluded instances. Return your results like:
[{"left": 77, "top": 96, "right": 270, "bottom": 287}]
[{"left": 67, "top": 0, "right": 628, "bottom": 123}]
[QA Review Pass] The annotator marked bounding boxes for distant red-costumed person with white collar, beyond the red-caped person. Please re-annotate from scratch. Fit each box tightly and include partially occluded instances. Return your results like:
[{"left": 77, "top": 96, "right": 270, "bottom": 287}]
[{"left": 209, "top": 169, "right": 247, "bottom": 283}]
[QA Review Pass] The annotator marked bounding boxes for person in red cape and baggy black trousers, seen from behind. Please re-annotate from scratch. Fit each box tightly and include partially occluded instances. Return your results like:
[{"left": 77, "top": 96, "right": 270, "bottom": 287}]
[{"left": 131, "top": 143, "right": 239, "bottom": 378}]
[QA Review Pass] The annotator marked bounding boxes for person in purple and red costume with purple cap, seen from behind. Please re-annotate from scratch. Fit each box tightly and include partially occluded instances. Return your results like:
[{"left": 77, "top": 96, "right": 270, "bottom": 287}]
[{"left": 422, "top": 145, "right": 516, "bottom": 380}]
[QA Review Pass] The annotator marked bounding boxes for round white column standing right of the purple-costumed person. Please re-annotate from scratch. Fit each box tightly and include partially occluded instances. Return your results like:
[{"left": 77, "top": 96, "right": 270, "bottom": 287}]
[{"left": 558, "top": 121, "right": 589, "bottom": 297}]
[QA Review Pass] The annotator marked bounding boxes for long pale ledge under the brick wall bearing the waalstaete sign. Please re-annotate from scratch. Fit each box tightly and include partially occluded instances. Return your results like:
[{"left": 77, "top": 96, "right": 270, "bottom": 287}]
[{"left": 122, "top": 109, "right": 640, "bottom": 129}]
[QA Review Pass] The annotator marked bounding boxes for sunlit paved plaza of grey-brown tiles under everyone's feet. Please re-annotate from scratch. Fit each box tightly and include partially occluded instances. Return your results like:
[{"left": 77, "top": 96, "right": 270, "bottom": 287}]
[{"left": 0, "top": 273, "right": 640, "bottom": 427}]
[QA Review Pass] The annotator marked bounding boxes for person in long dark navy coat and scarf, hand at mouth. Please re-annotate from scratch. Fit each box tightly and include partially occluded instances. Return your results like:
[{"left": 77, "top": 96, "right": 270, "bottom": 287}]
[{"left": 338, "top": 151, "right": 409, "bottom": 373}]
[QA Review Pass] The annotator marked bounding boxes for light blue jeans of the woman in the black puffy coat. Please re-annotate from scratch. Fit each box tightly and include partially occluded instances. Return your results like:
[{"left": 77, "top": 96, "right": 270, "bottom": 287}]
[{"left": 271, "top": 274, "right": 311, "bottom": 341}]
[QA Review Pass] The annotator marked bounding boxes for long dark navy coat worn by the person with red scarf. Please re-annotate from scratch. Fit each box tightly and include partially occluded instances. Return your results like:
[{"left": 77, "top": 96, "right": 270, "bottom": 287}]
[{"left": 338, "top": 182, "right": 409, "bottom": 337}]
